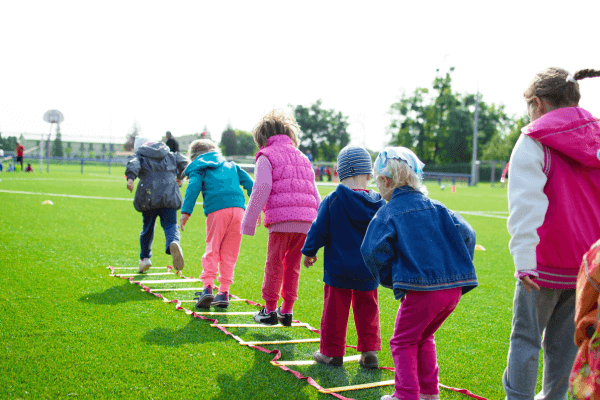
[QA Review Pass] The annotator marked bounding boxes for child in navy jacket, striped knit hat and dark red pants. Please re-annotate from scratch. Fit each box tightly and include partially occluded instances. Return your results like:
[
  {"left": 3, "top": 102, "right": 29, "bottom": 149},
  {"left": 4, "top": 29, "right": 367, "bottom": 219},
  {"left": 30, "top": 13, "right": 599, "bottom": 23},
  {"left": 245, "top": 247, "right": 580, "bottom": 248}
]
[{"left": 302, "top": 146, "right": 385, "bottom": 368}]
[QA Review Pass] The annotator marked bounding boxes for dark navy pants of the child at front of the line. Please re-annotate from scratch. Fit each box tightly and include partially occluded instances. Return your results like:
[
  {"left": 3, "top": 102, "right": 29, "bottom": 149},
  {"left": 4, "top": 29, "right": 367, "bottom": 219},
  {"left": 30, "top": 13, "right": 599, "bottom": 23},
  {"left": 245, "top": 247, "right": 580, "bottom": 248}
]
[{"left": 140, "top": 208, "right": 179, "bottom": 260}]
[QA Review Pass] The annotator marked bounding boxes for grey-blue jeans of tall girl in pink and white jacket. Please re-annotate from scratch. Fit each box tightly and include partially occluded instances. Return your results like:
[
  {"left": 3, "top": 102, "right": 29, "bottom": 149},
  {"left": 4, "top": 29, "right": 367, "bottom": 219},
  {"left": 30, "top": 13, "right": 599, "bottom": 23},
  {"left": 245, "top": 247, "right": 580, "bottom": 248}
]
[{"left": 502, "top": 281, "right": 577, "bottom": 400}]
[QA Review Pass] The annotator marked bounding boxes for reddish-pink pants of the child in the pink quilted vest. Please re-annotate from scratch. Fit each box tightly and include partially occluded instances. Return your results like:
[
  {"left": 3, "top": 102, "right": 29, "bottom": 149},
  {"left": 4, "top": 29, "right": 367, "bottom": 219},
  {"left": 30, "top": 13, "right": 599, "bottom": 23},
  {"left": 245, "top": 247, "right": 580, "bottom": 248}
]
[{"left": 262, "top": 232, "right": 306, "bottom": 313}]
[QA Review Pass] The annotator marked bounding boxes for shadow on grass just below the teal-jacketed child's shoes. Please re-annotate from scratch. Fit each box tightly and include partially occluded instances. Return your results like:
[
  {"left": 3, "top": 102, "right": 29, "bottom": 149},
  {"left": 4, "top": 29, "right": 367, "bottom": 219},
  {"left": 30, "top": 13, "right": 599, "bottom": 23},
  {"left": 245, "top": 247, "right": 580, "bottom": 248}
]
[{"left": 142, "top": 316, "right": 231, "bottom": 347}]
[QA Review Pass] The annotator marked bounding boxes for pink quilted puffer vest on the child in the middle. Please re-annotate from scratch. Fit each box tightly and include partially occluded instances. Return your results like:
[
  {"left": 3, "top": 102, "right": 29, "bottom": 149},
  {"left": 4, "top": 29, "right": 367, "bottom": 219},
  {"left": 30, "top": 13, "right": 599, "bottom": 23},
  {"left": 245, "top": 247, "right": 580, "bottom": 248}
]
[{"left": 256, "top": 135, "right": 317, "bottom": 226}]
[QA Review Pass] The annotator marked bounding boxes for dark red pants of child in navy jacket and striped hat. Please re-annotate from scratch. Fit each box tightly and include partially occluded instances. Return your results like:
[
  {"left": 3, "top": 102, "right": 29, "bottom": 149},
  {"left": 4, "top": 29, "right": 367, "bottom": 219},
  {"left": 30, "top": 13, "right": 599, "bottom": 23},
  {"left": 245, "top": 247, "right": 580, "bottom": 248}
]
[{"left": 320, "top": 284, "right": 381, "bottom": 357}]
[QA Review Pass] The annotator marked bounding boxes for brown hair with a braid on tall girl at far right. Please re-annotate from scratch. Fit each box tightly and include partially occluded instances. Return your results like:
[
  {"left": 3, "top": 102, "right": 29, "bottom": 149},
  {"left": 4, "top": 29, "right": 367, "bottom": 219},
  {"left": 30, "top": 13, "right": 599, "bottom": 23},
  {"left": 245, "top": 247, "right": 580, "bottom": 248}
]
[{"left": 523, "top": 67, "right": 600, "bottom": 108}]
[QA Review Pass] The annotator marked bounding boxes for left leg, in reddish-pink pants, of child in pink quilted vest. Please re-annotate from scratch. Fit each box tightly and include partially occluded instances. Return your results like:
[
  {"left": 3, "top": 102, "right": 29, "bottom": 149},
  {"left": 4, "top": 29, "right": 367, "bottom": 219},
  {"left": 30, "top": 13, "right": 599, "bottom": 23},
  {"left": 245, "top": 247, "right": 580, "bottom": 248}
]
[{"left": 262, "top": 232, "right": 289, "bottom": 312}]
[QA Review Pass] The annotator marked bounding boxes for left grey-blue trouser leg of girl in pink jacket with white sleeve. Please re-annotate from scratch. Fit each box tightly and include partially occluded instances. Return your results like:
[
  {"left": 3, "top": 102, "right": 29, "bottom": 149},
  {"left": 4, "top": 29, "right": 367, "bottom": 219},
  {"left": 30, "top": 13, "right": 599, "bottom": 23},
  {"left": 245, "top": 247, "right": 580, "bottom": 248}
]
[{"left": 502, "top": 281, "right": 574, "bottom": 400}]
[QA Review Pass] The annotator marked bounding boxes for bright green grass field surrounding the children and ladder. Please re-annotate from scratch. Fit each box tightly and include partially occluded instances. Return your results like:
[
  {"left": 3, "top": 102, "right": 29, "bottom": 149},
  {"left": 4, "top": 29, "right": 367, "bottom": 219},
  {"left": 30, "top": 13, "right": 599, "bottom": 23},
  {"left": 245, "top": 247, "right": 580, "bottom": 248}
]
[{"left": 0, "top": 170, "right": 536, "bottom": 399}]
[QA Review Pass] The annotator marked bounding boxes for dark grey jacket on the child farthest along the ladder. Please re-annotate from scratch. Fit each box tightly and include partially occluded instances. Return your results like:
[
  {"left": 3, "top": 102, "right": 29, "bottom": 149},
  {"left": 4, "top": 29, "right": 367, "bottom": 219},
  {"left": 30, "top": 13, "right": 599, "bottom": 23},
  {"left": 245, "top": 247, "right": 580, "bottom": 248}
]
[{"left": 125, "top": 142, "right": 188, "bottom": 212}]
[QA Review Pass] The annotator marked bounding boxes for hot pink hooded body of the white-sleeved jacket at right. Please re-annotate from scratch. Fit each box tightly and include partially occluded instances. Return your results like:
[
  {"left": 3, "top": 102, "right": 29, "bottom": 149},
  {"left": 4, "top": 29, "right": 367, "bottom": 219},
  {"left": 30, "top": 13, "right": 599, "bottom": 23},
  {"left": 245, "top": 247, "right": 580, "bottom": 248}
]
[{"left": 523, "top": 107, "right": 600, "bottom": 289}]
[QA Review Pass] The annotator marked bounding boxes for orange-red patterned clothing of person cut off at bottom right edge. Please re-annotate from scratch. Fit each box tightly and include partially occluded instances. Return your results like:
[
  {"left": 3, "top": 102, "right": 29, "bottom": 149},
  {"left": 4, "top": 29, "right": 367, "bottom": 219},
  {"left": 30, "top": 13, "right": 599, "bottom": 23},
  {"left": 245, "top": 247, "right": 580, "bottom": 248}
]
[{"left": 569, "top": 240, "right": 600, "bottom": 400}]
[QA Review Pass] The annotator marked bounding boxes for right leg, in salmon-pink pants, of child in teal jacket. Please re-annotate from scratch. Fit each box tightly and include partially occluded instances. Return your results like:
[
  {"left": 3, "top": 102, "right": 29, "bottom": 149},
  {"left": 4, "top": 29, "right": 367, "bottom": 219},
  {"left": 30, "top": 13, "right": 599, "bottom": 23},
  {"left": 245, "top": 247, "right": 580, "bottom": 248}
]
[{"left": 219, "top": 207, "right": 244, "bottom": 292}]
